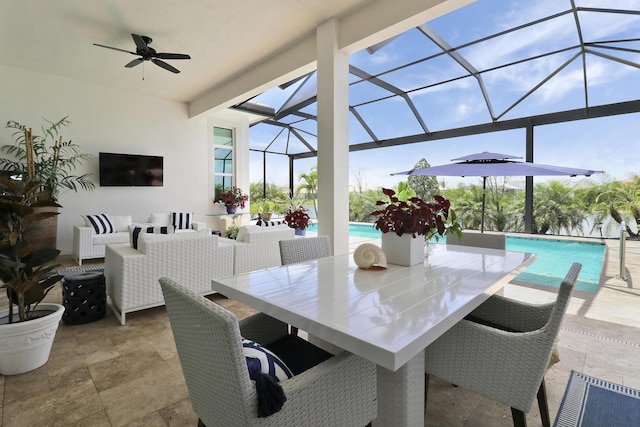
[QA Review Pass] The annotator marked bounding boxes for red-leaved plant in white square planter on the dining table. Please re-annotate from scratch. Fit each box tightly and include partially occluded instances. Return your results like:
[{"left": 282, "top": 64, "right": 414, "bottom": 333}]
[{"left": 371, "top": 182, "right": 462, "bottom": 266}]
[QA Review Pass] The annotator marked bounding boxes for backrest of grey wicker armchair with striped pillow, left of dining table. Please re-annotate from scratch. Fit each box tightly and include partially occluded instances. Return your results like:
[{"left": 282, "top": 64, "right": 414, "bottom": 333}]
[{"left": 160, "top": 277, "right": 255, "bottom": 425}]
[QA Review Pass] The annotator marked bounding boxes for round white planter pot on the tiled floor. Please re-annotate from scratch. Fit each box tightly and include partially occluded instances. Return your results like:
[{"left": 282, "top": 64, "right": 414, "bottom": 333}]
[{"left": 0, "top": 303, "right": 64, "bottom": 375}]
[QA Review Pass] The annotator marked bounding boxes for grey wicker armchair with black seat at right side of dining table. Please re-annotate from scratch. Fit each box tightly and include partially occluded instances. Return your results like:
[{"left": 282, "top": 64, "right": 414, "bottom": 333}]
[{"left": 425, "top": 263, "right": 582, "bottom": 426}]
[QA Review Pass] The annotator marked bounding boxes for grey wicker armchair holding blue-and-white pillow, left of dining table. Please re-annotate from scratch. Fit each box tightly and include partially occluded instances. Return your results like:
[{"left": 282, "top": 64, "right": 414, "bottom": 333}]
[{"left": 160, "top": 278, "right": 377, "bottom": 427}]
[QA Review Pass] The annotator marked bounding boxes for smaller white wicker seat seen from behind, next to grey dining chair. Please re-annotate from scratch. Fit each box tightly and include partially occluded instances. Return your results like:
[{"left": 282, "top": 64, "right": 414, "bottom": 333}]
[{"left": 231, "top": 225, "right": 295, "bottom": 274}]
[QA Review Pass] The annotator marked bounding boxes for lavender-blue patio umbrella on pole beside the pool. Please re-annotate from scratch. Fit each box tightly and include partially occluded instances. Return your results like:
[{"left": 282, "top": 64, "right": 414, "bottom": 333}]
[{"left": 391, "top": 151, "right": 602, "bottom": 232}]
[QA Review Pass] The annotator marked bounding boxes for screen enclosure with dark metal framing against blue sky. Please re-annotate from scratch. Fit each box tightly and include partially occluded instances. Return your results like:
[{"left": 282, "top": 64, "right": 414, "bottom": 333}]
[{"left": 236, "top": 0, "right": 640, "bottom": 231}]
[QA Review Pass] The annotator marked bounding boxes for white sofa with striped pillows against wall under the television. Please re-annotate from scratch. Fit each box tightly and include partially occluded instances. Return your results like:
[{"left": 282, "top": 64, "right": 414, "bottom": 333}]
[{"left": 73, "top": 213, "right": 207, "bottom": 265}]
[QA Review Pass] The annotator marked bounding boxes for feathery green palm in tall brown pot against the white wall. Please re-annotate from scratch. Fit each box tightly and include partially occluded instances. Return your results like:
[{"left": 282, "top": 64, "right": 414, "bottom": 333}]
[{"left": 0, "top": 117, "right": 95, "bottom": 248}]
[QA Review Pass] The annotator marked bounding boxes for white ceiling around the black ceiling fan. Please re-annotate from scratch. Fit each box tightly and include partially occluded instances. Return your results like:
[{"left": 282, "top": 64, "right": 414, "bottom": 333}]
[{"left": 0, "top": 0, "right": 468, "bottom": 111}]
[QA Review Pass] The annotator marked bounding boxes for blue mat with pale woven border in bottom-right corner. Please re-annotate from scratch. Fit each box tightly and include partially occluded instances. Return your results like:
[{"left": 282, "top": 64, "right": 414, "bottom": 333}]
[{"left": 554, "top": 371, "right": 640, "bottom": 427}]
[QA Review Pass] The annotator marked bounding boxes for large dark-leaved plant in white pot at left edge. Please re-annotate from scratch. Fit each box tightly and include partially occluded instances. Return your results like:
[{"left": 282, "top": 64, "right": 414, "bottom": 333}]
[{"left": 0, "top": 177, "right": 64, "bottom": 375}]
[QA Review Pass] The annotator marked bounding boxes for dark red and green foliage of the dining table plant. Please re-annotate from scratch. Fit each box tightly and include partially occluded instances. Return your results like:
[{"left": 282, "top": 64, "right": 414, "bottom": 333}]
[{"left": 371, "top": 183, "right": 462, "bottom": 240}]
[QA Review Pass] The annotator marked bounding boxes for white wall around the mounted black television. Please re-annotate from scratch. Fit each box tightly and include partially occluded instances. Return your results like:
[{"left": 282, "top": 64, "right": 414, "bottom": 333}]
[{"left": 0, "top": 64, "right": 230, "bottom": 254}]
